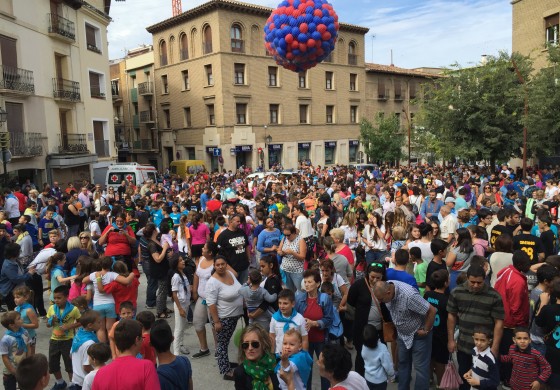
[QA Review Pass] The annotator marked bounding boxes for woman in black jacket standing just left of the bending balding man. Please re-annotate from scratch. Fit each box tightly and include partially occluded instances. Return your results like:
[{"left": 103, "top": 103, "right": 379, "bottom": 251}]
[{"left": 347, "top": 263, "right": 391, "bottom": 376}]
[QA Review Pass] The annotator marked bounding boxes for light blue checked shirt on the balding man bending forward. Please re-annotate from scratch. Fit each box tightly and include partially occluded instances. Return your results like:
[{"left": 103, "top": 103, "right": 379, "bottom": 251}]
[{"left": 386, "top": 280, "right": 430, "bottom": 349}]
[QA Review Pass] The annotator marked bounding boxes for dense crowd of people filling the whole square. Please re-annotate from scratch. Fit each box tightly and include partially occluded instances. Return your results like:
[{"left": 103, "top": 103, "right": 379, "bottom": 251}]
[{"left": 0, "top": 164, "right": 560, "bottom": 390}]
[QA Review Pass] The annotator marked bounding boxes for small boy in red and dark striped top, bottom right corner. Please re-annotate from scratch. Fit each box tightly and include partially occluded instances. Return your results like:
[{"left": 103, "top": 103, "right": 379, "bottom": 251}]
[{"left": 500, "top": 327, "right": 551, "bottom": 390}]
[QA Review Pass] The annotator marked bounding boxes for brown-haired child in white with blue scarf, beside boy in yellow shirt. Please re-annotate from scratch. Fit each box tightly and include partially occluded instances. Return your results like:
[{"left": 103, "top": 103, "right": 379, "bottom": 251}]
[{"left": 68, "top": 310, "right": 101, "bottom": 390}]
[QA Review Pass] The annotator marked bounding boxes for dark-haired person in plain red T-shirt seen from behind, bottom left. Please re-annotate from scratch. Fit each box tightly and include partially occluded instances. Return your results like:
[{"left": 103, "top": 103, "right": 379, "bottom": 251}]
[{"left": 91, "top": 319, "right": 161, "bottom": 390}]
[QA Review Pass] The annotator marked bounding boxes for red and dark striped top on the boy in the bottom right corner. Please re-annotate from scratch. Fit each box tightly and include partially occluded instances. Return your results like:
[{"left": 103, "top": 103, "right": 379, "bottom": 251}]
[{"left": 500, "top": 344, "right": 552, "bottom": 390}]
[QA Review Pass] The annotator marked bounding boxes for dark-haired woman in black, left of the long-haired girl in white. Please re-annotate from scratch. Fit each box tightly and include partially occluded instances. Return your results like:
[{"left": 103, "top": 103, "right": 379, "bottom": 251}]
[{"left": 140, "top": 222, "right": 171, "bottom": 318}]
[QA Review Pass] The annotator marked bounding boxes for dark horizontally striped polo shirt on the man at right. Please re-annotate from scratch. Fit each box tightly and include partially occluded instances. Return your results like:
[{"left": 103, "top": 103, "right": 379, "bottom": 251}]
[{"left": 447, "top": 281, "right": 505, "bottom": 354}]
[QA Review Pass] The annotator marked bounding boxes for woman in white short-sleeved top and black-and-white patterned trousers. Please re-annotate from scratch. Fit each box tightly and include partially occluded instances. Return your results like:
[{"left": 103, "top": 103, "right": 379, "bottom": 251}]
[{"left": 206, "top": 256, "right": 243, "bottom": 381}]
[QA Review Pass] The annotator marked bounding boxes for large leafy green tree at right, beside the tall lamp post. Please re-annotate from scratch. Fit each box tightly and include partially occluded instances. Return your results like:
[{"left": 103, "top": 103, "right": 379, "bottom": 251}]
[{"left": 417, "top": 52, "right": 531, "bottom": 163}]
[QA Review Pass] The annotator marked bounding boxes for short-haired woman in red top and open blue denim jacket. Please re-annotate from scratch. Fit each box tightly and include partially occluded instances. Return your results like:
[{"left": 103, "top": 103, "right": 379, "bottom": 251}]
[{"left": 295, "top": 270, "right": 334, "bottom": 390}]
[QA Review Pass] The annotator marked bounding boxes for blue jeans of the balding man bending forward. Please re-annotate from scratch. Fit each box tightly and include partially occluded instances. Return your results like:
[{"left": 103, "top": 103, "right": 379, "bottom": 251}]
[{"left": 397, "top": 332, "right": 433, "bottom": 390}]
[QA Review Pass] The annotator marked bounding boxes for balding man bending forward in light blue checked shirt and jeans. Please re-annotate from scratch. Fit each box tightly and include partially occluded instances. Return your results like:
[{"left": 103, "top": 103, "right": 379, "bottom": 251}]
[{"left": 374, "top": 281, "right": 437, "bottom": 390}]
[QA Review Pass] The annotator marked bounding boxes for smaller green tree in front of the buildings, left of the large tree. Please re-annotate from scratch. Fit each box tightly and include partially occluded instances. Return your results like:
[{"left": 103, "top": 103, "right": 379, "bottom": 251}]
[{"left": 360, "top": 115, "right": 404, "bottom": 163}]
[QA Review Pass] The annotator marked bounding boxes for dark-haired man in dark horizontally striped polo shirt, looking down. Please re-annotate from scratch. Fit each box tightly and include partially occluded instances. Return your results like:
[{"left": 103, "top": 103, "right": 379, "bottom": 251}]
[{"left": 448, "top": 265, "right": 505, "bottom": 390}]
